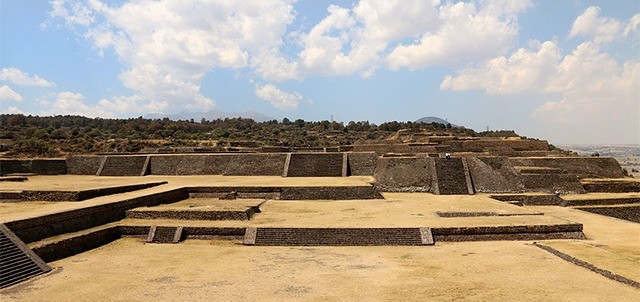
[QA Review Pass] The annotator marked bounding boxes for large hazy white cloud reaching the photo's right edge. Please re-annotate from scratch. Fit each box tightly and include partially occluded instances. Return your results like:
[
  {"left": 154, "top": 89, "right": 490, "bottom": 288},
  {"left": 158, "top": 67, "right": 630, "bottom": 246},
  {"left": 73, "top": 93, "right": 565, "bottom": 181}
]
[{"left": 440, "top": 7, "right": 640, "bottom": 141}]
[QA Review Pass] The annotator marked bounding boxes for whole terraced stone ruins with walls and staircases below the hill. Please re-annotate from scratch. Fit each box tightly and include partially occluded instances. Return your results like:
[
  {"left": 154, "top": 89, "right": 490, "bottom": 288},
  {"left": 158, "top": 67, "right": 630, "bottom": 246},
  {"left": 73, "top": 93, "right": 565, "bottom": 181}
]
[{"left": 0, "top": 135, "right": 640, "bottom": 287}]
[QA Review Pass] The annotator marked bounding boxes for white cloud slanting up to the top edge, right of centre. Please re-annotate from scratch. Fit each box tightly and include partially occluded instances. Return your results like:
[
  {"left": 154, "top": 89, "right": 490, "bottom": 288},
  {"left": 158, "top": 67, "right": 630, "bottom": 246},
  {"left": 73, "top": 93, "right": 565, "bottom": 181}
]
[{"left": 387, "top": 1, "right": 530, "bottom": 70}]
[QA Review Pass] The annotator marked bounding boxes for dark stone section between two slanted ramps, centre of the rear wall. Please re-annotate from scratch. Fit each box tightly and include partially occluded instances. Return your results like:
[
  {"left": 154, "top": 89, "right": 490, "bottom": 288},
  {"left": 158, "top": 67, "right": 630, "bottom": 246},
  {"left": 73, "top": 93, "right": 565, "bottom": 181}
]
[{"left": 285, "top": 153, "right": 346, "bottom": 177}]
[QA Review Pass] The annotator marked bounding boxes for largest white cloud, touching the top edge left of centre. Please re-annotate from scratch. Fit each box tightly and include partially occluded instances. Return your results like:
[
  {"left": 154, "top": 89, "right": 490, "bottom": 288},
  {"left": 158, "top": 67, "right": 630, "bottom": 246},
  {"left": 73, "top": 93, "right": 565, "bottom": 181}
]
[{"left": 51, "top": 0, "right": 296, "bottom": 110}]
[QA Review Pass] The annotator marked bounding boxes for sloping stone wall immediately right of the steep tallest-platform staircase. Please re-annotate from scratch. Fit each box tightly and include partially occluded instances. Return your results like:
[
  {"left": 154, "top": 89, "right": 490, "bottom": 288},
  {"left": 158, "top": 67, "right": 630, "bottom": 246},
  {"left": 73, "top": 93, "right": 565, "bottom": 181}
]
[{"left": 466, "top": 156, "right": 524, "bottom": 193}]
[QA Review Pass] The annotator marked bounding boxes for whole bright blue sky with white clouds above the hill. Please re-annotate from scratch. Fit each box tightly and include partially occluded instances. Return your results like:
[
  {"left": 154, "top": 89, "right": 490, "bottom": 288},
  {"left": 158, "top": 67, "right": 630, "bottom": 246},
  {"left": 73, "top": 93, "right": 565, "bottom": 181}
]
[{"left": 0, "top": 0, "right": 640, "bottom": 144}]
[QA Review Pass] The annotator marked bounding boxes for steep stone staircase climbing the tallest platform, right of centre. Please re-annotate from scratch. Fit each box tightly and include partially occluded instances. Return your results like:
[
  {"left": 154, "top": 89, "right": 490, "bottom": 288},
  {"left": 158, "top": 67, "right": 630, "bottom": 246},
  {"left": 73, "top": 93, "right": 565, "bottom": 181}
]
[{"left": 434, "top": 158, "right": 473, "bottom": 195}]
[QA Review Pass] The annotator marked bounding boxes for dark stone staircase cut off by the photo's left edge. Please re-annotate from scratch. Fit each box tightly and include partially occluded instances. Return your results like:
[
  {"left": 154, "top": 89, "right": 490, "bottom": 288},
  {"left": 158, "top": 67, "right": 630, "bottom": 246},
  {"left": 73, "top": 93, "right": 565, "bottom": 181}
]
[{"left": 0, "top": 224, "right": 51, "bottom": 288}]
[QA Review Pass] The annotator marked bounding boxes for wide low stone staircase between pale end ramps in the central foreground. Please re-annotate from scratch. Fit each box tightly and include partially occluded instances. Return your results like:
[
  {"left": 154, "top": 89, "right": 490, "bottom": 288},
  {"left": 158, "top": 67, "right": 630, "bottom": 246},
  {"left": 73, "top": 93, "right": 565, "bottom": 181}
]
[{"left": 244, "top": 228, "right": 434, "bottom": 246}]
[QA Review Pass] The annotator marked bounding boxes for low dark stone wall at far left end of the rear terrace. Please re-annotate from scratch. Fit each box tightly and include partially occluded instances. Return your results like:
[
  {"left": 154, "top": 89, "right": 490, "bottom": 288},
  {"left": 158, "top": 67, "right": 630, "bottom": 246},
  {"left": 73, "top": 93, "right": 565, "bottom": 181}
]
[{"left": 0, "top": 159, "right": 67, "bottom": 176}]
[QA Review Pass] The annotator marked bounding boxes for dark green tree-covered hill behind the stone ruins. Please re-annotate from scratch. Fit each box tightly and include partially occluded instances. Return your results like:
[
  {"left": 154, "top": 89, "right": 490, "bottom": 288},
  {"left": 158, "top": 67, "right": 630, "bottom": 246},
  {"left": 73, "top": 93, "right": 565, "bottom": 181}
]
[{"left": 0, "top": 114, "right": 517, "bottom": 157}]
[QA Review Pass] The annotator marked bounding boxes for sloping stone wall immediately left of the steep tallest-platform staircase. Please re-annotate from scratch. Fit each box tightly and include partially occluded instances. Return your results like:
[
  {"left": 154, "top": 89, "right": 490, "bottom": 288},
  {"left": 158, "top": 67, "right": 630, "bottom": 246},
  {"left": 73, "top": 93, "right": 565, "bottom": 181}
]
[{"left": 374, "top": 157, "right": 435, "bottom": 192}]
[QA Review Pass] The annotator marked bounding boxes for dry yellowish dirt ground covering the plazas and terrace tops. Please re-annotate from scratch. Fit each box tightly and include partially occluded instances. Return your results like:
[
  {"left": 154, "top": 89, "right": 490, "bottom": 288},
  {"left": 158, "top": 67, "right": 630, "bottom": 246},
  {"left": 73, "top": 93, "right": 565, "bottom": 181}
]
[{"left": 0, "top": 177, "right": 640, "bottom": 302}]
